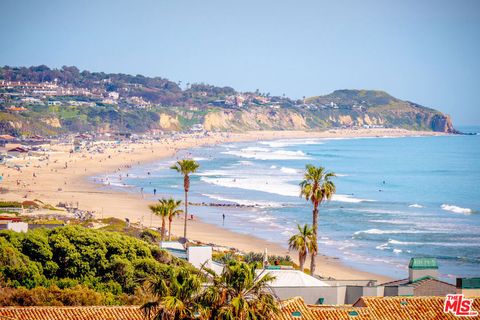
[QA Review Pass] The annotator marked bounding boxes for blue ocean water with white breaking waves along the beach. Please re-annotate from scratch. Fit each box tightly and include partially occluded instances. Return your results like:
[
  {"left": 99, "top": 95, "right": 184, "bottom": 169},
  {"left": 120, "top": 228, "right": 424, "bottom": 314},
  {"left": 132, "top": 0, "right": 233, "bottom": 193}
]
[{"left": 95, "top": 128, "right": 480, "bottom": 280}]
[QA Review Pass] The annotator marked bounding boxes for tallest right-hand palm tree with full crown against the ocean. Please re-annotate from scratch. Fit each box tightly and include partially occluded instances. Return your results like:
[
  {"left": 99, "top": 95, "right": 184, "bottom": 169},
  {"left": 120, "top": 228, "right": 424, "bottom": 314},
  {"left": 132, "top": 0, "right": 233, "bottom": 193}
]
[{"left": 300, "top": 164, "right": 335, "bottom": 276}]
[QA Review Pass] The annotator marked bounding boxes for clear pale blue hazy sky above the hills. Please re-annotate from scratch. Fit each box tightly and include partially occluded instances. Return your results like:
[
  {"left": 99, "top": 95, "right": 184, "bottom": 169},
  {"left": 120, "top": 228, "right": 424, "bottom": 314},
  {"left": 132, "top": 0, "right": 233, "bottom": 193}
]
[{"left": 0, "top": 0, "right": 480, "bottom": 125}]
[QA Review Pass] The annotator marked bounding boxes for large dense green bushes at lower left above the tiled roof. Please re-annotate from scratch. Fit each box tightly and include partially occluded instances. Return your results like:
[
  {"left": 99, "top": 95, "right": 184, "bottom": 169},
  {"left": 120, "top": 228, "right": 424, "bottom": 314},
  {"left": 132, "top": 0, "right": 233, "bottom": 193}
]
[{"left": 0, "top": 226, "right": 193, "bottom": 303}]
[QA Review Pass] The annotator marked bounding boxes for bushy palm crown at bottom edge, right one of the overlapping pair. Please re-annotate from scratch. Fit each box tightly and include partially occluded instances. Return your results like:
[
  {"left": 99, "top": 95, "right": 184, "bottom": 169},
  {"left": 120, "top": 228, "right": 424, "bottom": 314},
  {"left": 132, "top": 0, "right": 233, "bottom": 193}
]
[{"left": 201, "top": 261, "right": 279, "bottom": 320}]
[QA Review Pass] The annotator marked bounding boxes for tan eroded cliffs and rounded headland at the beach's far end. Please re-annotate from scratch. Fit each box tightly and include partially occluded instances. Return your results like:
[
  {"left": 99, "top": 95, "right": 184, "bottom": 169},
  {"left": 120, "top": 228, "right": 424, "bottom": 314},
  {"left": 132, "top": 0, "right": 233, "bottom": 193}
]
[{"left": 156, "top": 90, "right": 457, "bottom": 133}]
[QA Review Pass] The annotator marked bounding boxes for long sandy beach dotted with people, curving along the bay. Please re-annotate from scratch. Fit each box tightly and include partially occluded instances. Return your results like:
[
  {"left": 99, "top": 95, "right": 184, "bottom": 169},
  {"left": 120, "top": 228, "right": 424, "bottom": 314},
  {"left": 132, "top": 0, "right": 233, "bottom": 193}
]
[{"left": 0, "top": 129, "right": 446, "bottom": 281}]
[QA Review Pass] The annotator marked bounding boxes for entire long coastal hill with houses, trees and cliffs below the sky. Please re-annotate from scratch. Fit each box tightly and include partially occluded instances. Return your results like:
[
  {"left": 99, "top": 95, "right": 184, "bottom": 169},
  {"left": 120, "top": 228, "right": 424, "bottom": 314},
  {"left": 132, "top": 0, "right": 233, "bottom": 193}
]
[{"left": 0, "top": 66, "right": 456, "bottom": 136}]
